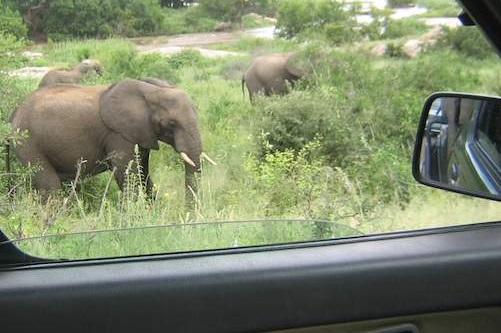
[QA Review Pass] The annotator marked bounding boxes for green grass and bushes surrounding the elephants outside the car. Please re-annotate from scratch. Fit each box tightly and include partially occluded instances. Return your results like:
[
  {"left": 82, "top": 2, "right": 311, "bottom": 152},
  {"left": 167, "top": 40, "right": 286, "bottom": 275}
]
[{"left": 0, "top": 0, "right": 501, "bottom": 258}]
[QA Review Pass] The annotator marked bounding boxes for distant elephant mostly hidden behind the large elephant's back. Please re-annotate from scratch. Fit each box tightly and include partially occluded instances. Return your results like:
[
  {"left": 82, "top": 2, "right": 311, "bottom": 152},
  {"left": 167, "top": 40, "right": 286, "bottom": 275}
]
[{"left": 38, "top": 59, "right": 103, "bottom": 88}]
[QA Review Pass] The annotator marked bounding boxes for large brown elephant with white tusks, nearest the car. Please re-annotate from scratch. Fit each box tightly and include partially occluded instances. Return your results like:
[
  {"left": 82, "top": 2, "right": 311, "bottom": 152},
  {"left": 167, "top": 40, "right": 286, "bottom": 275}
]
[{"left": 9, "top": 78, "right": 206, "bottom": 203}]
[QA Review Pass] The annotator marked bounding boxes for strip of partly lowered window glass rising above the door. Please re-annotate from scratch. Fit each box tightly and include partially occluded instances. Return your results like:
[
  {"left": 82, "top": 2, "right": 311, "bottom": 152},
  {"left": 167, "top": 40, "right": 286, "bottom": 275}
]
[{"left": 0, "top": 219, "right": 361, "bottom": 260}]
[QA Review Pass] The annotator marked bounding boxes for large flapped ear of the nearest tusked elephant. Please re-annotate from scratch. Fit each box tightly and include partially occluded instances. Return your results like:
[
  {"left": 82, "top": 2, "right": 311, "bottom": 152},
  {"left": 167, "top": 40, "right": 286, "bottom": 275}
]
[{"left": 99, "top": 79, "right": 158, "bottom": 149}]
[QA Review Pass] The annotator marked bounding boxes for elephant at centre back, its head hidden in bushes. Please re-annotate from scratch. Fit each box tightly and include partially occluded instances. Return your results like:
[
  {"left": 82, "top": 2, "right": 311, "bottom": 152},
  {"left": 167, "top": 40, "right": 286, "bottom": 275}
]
[{"left": 242, "top": 52, "right": 305, "bottom": 102}]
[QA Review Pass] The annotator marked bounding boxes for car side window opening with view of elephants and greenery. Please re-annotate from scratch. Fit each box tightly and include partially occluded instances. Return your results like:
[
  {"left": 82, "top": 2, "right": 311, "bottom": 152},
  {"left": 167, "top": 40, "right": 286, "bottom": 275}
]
[{"left": 0, "top": 0, "right": 501, "bottom": 259}]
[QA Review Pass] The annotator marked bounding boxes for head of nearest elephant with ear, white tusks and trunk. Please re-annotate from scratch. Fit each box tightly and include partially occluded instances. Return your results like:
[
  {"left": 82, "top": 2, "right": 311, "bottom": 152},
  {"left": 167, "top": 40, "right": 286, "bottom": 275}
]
[{"left": 99, "top": 79, "right": 202, "bottom": 202}]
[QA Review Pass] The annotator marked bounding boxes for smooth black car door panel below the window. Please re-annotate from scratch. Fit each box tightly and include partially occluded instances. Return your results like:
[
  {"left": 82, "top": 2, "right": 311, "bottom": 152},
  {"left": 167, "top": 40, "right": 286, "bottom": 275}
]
[{"left": 0, "top": 223, "right": 501, "bottom": 332}]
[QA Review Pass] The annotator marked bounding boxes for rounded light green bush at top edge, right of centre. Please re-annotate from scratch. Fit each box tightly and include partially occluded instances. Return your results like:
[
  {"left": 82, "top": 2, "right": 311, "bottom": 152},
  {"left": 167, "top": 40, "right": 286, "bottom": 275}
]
[{"left": 276, "top": 0, "right": 357, "bottom": 44}]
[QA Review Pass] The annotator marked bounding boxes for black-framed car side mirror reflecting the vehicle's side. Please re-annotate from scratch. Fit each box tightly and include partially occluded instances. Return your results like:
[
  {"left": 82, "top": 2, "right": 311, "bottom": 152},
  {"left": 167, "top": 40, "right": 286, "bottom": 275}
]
[{"left": 413, "top": 93, "right": 501, "bottom": 200}]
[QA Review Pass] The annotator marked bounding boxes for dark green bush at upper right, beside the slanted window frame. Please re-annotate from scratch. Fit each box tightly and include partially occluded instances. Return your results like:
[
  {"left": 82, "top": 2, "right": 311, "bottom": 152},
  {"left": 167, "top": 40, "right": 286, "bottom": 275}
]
[{"left": 437, "top": 26, "right": 492, "bottom": 59}]
